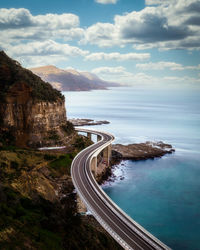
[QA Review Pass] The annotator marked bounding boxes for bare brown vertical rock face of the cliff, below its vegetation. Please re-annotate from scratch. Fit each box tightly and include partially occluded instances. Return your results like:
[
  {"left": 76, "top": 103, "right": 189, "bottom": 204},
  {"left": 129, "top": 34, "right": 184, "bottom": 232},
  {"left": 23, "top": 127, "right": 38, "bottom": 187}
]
[{"left": 0, "top": 83, "right": 66, "bottom": 147}]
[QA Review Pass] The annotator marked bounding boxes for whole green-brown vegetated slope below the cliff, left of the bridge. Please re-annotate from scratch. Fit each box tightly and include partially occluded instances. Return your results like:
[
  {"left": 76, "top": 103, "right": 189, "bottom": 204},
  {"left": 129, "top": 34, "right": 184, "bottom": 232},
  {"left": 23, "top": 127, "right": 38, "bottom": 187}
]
[{"left": 0, "top": 146, "right": 121, "bottom": 250}]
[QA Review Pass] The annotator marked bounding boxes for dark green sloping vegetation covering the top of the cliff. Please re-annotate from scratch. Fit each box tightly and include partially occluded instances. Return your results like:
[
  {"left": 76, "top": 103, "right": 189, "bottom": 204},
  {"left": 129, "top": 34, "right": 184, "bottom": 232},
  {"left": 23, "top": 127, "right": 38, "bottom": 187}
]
[{"left": 0, "top": 51, "right": 64, "bottom": 102}]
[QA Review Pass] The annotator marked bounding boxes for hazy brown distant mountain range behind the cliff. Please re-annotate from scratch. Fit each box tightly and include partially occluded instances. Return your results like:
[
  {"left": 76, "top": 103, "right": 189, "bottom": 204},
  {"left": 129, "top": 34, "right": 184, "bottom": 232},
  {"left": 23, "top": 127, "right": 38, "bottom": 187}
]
[{"left": 30, "top": 65, "right": 120, "bottom": 91}]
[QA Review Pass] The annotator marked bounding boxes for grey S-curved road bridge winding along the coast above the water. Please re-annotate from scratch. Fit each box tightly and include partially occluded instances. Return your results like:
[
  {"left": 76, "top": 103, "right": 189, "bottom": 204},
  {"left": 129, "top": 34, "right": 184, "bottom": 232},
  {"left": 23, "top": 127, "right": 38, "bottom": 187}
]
[{"left": 71, "top": 129, "right": 170, "bottom": 250}]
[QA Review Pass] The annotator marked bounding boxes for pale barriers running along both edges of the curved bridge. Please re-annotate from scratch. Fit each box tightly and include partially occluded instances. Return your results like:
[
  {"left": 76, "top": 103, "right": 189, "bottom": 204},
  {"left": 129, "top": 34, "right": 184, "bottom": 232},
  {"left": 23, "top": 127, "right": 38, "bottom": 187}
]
[{"left": 72, "top": 129, "right": 170, "bottom": 250}]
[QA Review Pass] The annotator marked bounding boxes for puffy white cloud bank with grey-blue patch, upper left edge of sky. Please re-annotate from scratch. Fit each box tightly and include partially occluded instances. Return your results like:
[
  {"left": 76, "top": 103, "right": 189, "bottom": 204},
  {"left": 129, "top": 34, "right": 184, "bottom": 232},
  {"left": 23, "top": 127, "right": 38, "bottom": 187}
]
[{"left": 0, "top": 8, "right": 84, "bottom": 42}]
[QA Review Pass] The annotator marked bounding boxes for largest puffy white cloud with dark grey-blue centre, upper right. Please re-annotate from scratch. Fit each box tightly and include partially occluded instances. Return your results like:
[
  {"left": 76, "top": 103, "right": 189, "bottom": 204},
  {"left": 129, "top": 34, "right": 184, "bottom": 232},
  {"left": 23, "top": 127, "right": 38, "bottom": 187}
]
[{"left": 81, "top": 0, "right": 200, "bottom": 49}]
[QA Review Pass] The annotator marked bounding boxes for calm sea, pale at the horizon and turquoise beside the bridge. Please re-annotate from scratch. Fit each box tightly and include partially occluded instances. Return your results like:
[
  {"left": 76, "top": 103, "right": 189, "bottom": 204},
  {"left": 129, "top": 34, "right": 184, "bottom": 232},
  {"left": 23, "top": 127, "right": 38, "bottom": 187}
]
[{"left": 65, "top": 88, "right": 200, "bottom": 250}]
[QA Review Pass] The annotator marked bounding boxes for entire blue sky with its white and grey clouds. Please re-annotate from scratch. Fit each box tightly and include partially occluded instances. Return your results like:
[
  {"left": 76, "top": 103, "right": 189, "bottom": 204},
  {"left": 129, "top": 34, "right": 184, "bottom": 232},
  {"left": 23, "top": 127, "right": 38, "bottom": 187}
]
[{"left": 0, "top": 0, "right": 200, "bottom": 88}]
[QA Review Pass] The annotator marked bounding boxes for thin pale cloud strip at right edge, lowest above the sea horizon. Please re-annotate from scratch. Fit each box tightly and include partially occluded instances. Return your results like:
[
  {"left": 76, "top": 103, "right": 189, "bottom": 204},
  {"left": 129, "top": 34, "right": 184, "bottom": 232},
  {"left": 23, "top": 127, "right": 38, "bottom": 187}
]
[{"left": 136, "top": 61, "right": 200, "bottom": 70}]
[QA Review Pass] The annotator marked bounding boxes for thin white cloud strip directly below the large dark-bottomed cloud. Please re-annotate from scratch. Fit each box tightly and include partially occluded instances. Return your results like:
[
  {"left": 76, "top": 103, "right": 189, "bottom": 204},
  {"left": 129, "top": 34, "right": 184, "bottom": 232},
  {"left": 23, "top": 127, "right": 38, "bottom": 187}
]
[{"left": 85, "top": 52, "right": 150, "bottom": 61}]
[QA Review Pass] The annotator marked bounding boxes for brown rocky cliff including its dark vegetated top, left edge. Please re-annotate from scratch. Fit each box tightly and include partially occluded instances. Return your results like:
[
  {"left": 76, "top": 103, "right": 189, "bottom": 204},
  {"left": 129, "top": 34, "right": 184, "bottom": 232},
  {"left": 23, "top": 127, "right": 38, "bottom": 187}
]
[{"left": 0, "top": 51, "right": 73, "bottom": 147}]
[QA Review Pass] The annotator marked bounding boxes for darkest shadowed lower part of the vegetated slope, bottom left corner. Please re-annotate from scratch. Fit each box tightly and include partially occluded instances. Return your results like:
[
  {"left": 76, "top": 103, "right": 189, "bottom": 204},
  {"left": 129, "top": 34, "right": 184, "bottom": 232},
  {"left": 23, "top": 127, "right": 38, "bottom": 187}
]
[{"left": 0, "top": 187, "right": 121, "bottom": 250}]
